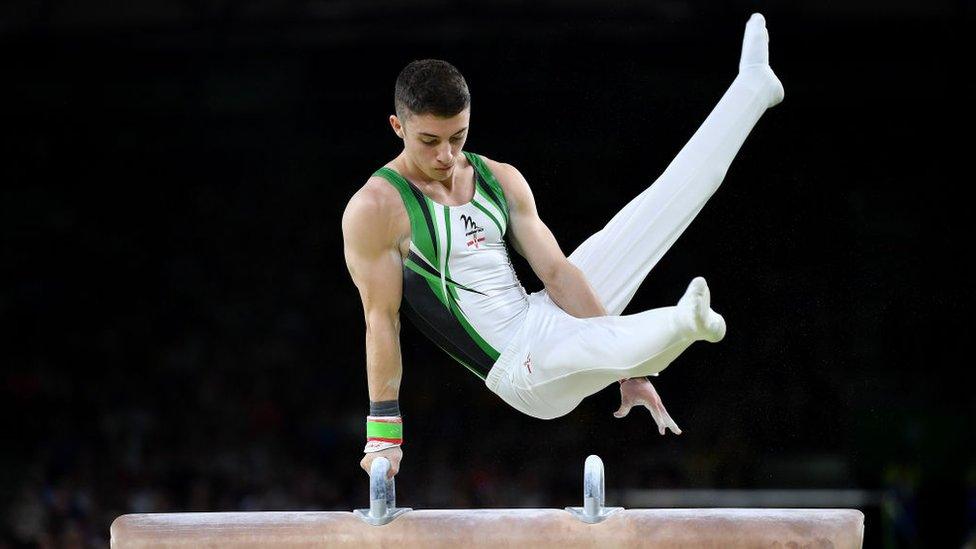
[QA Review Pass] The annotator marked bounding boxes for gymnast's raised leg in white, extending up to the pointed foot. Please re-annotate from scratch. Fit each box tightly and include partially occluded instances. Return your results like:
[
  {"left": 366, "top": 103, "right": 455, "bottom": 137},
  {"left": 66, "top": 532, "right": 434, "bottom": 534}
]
[{"left": 569, "top": 15, "right": 783, "bottom": 315}]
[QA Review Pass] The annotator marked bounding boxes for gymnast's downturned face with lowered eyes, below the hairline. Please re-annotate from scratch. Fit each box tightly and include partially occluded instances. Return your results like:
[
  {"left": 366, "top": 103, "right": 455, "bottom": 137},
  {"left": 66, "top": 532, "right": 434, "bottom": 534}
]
[{"left": 390, "top": 109, "right": 471, "bottom": 181}]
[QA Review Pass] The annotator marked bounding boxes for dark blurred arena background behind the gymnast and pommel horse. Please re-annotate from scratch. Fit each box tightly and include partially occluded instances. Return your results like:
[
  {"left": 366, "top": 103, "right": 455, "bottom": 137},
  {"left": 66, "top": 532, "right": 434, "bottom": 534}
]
[{"left": 0, "top": 0, "right": 976, "bottom": 547}]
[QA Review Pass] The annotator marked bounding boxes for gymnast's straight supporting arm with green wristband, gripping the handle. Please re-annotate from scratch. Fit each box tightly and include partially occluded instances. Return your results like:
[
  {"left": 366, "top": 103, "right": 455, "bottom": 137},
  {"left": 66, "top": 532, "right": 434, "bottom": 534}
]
[{"left": 342, "top": 183, "right": 403, "bottom": 477}]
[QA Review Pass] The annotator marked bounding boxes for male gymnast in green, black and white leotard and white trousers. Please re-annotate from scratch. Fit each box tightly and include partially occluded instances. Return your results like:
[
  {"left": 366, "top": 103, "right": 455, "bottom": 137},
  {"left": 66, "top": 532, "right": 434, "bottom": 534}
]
[{"left": 342, "top": 14, "right": 783, "bottom": 476}]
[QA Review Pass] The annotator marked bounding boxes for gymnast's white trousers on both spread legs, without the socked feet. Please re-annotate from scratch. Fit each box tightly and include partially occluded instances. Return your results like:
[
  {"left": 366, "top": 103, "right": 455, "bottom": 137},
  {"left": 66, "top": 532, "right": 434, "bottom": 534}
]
[{"left": 485, "top": 50, "right": 783, "bottom": 419}]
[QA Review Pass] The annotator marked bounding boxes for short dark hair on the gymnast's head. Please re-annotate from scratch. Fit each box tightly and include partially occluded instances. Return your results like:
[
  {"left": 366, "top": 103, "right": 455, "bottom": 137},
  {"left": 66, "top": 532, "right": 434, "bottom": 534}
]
[{"left": 394, "top": 59, "right": 471, "bottom": 119}]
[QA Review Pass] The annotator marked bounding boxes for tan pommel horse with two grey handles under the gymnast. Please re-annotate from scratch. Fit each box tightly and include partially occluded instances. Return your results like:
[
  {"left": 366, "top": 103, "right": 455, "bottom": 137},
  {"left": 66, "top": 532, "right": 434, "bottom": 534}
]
[{"left": 111, "top": 455, "right": 864, "bottom": 549}]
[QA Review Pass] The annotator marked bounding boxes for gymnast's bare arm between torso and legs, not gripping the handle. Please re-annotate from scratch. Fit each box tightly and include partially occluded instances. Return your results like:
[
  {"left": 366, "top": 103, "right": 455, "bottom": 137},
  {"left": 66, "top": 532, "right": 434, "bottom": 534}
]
[{"left": 491, "top": 162, "right": 607, "bottom": 318}]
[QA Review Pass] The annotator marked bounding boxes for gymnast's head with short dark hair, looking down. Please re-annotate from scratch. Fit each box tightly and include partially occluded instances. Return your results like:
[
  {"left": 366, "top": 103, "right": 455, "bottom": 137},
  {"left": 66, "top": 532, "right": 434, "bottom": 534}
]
[{"left": 390, "top": 59, "right": 471, "bottom": 181}]
